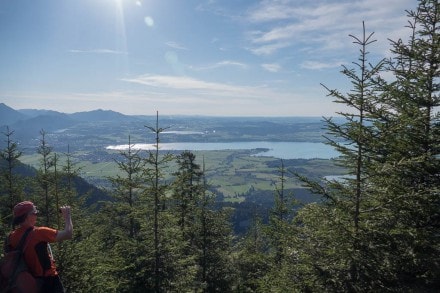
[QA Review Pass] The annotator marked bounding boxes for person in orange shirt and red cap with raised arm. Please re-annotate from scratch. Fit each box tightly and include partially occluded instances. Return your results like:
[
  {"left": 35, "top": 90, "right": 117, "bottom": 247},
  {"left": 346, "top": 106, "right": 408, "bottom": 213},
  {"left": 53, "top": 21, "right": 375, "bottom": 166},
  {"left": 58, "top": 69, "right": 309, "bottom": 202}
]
[{"left": 5, "top": 201, "right": 73, "bottom": 293}]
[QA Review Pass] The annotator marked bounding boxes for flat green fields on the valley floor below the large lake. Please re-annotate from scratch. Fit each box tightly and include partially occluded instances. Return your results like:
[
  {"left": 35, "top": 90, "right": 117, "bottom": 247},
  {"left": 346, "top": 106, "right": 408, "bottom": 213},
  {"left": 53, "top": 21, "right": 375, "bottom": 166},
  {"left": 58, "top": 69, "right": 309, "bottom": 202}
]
[{"left": 21, "top": 150, "right": 343, "bottom": 201}]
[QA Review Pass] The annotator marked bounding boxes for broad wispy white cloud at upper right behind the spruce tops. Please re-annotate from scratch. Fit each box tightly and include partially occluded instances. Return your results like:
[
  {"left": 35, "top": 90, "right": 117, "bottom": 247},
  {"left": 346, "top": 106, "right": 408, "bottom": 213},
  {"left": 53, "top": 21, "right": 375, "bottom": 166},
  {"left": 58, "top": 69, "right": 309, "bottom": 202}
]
[{"left": 247, "top": 0, "right": 414, "bottom": 55}]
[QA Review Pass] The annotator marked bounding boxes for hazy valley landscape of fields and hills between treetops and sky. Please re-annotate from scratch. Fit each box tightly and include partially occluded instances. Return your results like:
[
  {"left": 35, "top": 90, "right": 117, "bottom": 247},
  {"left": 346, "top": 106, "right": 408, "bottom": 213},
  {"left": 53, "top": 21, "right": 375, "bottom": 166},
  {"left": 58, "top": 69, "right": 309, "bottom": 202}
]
[{"left": 0, "top": 102, "right": 345, "bottom": 228}]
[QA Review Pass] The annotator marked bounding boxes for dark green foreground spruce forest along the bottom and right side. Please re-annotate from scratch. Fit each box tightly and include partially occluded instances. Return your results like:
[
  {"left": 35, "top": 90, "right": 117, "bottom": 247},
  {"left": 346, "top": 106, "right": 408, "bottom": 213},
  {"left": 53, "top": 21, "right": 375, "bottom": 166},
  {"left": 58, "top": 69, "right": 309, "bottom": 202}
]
[{"left": 0, "top": 0, "right": 440, "bottom": 292}]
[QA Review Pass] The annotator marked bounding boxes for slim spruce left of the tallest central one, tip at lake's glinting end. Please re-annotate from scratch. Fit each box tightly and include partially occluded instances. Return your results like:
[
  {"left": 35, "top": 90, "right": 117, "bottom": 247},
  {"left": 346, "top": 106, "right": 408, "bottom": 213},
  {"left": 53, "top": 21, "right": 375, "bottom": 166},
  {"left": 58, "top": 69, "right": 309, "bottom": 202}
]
[{"left": 93, "top": 136, "right": 152, "bottom": 292}]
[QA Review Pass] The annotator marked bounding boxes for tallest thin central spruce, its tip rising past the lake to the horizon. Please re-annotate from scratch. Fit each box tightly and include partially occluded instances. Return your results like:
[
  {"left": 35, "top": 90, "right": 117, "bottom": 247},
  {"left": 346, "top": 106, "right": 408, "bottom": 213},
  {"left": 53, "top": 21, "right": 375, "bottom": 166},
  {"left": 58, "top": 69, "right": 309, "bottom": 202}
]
[{"left": 142, "top": 113, "right": 193, "bottom": 292}]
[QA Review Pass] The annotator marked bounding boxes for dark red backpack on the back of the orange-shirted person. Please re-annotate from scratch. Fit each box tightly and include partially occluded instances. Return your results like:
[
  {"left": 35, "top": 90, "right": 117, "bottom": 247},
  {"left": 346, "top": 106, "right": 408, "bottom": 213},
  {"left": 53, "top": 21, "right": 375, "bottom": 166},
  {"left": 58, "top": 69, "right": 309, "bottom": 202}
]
[{"left": 0, "top": 227, "right": 37, "bottom": 293}]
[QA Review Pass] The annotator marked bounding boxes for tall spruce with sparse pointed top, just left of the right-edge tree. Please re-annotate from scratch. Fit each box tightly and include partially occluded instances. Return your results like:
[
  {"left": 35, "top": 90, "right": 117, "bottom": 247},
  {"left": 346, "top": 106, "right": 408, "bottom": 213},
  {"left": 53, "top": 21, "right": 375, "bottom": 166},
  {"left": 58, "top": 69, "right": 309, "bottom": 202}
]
[{"left": 298, "top": 21, "right": 384, "bottom": 292}]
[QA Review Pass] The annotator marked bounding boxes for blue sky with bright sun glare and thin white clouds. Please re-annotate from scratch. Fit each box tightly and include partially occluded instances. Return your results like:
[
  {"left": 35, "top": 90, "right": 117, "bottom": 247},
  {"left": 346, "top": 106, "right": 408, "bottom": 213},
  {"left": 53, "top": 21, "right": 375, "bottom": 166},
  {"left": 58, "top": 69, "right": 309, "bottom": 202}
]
[{"left": 0, "top": 0, "right": 417, "bottom": 116}]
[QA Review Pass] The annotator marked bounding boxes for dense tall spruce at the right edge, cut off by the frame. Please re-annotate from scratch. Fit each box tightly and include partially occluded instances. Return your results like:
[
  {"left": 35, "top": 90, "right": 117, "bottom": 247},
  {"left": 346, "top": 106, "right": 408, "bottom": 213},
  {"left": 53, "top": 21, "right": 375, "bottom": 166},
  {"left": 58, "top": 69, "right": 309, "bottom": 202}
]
[{"left": 368, "top": 0, "right": 440, "bottom": 292}]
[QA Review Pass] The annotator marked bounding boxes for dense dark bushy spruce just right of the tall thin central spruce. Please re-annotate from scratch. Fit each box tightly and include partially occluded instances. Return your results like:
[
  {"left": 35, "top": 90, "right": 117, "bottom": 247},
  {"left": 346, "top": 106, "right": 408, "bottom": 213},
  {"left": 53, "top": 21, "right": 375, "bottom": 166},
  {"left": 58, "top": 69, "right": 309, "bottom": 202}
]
[{"left": 172, "top": 151, "right": 232, "bottom": 292}]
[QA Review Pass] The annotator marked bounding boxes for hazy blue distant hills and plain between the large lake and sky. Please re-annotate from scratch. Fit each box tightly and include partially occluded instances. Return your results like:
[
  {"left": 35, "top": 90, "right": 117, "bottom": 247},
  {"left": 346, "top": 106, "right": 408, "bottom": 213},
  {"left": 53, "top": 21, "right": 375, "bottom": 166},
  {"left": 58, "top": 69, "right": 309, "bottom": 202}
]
[{"left": 0, "top": 103, "right": 338, "bottom": 149}]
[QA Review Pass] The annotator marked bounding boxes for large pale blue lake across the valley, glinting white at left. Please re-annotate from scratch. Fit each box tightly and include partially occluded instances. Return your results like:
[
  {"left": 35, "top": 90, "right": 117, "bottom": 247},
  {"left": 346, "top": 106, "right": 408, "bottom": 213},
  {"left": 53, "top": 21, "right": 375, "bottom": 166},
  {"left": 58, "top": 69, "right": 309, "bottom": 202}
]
[{"left": 106, "top": 141, "right": 339, "bottom": 159}]
